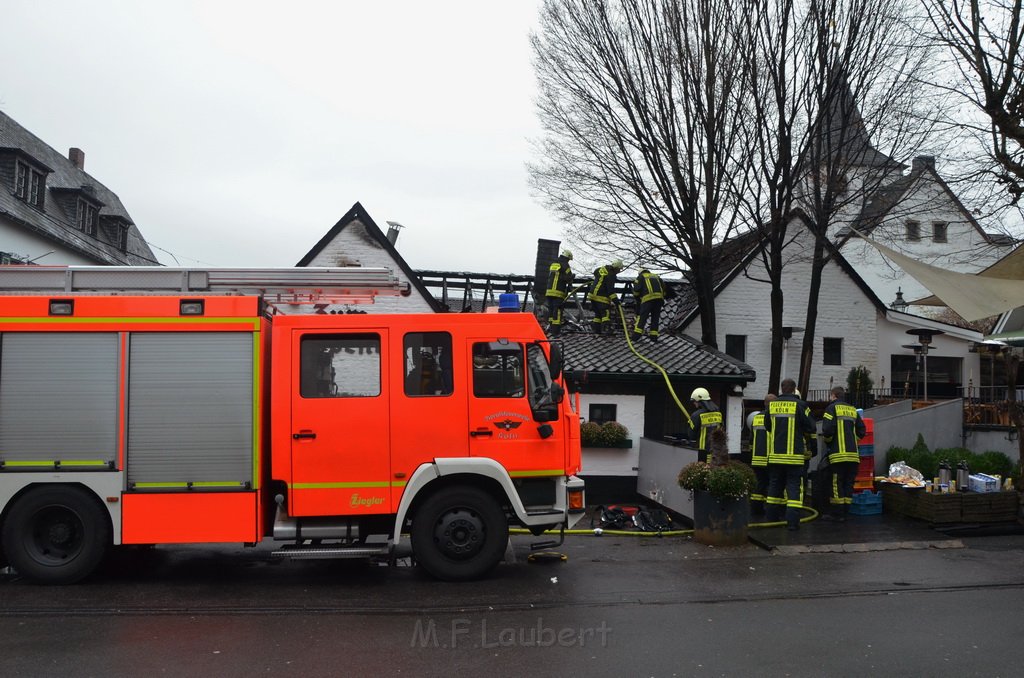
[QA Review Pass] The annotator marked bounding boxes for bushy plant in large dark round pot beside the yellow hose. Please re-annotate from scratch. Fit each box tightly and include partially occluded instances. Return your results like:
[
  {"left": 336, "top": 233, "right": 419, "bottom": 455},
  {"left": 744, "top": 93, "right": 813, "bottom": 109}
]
[{"left": 678, "top": 428, "right": 757, "bottom": 546}]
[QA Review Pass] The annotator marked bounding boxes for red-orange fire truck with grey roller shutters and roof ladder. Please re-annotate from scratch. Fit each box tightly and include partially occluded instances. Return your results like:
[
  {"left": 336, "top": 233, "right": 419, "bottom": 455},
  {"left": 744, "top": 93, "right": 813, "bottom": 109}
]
[{"left": 0, "top": 266, "right": 584, "bottom": 583}]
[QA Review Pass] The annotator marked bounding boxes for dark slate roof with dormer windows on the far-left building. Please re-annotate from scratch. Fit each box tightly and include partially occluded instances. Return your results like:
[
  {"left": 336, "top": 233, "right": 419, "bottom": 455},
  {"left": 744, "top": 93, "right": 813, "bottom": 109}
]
[{"left": 0, "top": 111, "right": 160, "bottom": 265}]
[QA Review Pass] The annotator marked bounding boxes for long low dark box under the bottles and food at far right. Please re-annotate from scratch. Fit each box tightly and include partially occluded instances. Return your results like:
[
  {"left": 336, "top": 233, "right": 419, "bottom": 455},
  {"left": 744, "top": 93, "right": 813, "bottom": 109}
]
[{"left": 880, "top": 482, "right": 1019, "bottom": 523}]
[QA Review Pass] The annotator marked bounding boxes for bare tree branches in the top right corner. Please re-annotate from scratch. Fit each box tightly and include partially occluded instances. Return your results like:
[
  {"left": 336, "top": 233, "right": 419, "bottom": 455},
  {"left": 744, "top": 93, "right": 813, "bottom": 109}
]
[{"left": 925, "top": 0, "right": 1024, "bottom": 205}]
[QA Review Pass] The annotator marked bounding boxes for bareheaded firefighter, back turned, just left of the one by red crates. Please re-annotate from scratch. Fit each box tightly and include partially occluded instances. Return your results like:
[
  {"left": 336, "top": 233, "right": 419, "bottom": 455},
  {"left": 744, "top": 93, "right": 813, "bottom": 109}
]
[{"left": 765, "top": 379, "right": 817, "bottom": 531}]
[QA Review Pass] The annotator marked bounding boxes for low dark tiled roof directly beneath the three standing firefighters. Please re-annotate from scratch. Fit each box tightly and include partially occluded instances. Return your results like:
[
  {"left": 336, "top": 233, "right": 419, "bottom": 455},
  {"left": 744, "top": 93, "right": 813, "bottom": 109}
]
[{"left": 560, "top": 321, "right": 756, "bottom": 382}]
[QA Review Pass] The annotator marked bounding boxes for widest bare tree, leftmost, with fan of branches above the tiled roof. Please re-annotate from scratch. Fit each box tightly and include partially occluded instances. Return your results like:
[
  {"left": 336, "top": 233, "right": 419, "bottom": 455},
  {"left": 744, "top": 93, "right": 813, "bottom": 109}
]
[{"left": 529, "top": 0, "right": 749, "bottom": 346}]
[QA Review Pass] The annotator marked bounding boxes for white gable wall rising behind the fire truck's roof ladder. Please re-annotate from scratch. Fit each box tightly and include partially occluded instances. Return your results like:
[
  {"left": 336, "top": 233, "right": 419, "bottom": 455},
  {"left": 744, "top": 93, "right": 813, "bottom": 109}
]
[{"left": 299, "top": 221, "right": 433, "bottom": 313}]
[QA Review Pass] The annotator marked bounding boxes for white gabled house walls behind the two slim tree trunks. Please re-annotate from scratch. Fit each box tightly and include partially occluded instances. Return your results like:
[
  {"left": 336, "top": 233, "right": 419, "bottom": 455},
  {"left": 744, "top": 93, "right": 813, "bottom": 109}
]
[{"left": 678, "top": 219, "right": 982, "bottom": 399}]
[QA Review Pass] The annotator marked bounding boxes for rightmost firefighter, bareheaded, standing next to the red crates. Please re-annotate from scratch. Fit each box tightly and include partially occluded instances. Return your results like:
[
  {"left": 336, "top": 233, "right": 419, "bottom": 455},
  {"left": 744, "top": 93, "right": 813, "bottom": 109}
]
[{"left": 821, "top": 386, "right": 867, "bottom": 522}]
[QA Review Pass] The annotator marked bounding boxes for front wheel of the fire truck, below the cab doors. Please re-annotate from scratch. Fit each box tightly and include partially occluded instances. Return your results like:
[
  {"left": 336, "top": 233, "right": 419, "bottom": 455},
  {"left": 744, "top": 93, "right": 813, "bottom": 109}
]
[{"left": 411, "top": 486, "right": 509, "bottom": 582}]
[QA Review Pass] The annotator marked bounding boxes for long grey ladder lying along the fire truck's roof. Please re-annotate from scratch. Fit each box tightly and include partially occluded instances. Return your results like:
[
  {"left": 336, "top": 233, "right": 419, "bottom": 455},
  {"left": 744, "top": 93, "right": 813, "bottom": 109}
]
[{"left": 0, "top": 265, "right": 410, "bottom": 304}]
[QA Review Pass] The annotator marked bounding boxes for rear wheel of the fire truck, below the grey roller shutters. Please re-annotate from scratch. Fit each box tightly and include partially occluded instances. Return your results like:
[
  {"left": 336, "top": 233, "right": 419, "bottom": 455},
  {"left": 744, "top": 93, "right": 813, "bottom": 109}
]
[{"left": 0, "top": 486, "right": 111, "bottom": 584}]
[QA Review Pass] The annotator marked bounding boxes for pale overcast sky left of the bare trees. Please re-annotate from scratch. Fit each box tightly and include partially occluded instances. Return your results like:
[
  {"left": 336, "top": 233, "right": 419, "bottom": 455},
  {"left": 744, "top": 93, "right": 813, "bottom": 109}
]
[{"left": 0, "top": 0, "right": 562, "bottom": 273}]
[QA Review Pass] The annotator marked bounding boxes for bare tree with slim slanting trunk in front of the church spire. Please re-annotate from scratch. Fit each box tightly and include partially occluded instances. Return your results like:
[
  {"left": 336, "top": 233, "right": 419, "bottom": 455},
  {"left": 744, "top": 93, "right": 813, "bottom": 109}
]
[{"left": 798, "top": 0, "right": 931, "bottom": 389}]
